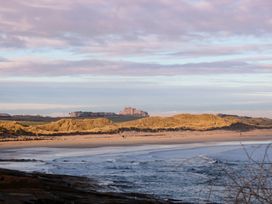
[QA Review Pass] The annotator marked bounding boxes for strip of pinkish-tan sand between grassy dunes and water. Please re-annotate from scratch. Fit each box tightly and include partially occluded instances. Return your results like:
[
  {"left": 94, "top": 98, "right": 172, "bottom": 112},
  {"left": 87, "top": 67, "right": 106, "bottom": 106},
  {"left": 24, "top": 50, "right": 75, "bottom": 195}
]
[{"left": 0, "top": 129, "right": 272, "bottom": 149}]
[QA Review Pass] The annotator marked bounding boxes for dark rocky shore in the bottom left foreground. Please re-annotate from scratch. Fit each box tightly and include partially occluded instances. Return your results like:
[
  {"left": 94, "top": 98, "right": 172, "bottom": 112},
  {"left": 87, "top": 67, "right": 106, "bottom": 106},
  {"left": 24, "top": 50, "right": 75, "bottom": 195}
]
[{"left": 0, "top": 169, "right": 176, "bottom": 204}]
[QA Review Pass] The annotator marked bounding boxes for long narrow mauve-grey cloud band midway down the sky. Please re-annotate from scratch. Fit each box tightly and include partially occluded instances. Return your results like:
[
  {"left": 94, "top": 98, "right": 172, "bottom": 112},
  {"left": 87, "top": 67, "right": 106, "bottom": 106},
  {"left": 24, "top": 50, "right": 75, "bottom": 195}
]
[{"left": 0, "top": 59, "right": 271, "bottom": 76}]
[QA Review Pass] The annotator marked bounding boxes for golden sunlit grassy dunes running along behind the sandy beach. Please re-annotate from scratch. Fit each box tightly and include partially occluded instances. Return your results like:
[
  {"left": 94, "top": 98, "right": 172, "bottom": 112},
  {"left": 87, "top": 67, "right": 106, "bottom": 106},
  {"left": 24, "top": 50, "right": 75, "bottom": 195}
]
[{"left": 0, "top": 114, "right": 272, "bottom": 136}]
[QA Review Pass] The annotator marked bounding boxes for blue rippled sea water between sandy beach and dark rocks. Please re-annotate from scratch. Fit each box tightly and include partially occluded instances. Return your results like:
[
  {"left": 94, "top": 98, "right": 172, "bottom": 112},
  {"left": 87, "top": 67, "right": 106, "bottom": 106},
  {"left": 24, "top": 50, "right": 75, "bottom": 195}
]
[{"left": 0, "top": 141, "right": 272, "bottom": 203}]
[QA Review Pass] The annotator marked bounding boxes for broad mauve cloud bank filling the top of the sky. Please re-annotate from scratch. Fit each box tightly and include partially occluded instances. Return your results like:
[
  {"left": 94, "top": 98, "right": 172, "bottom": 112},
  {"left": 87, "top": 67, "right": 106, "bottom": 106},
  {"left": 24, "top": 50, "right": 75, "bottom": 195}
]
[{"left": 0, "top": 0, "right": 272, "bottom": 46}]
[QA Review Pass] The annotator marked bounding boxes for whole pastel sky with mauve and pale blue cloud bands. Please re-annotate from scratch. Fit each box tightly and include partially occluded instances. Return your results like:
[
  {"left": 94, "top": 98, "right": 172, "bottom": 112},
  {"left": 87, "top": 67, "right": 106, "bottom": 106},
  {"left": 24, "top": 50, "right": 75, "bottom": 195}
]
[{"left": 0, "top": 0, "right": 272, "bottom": 117}]
